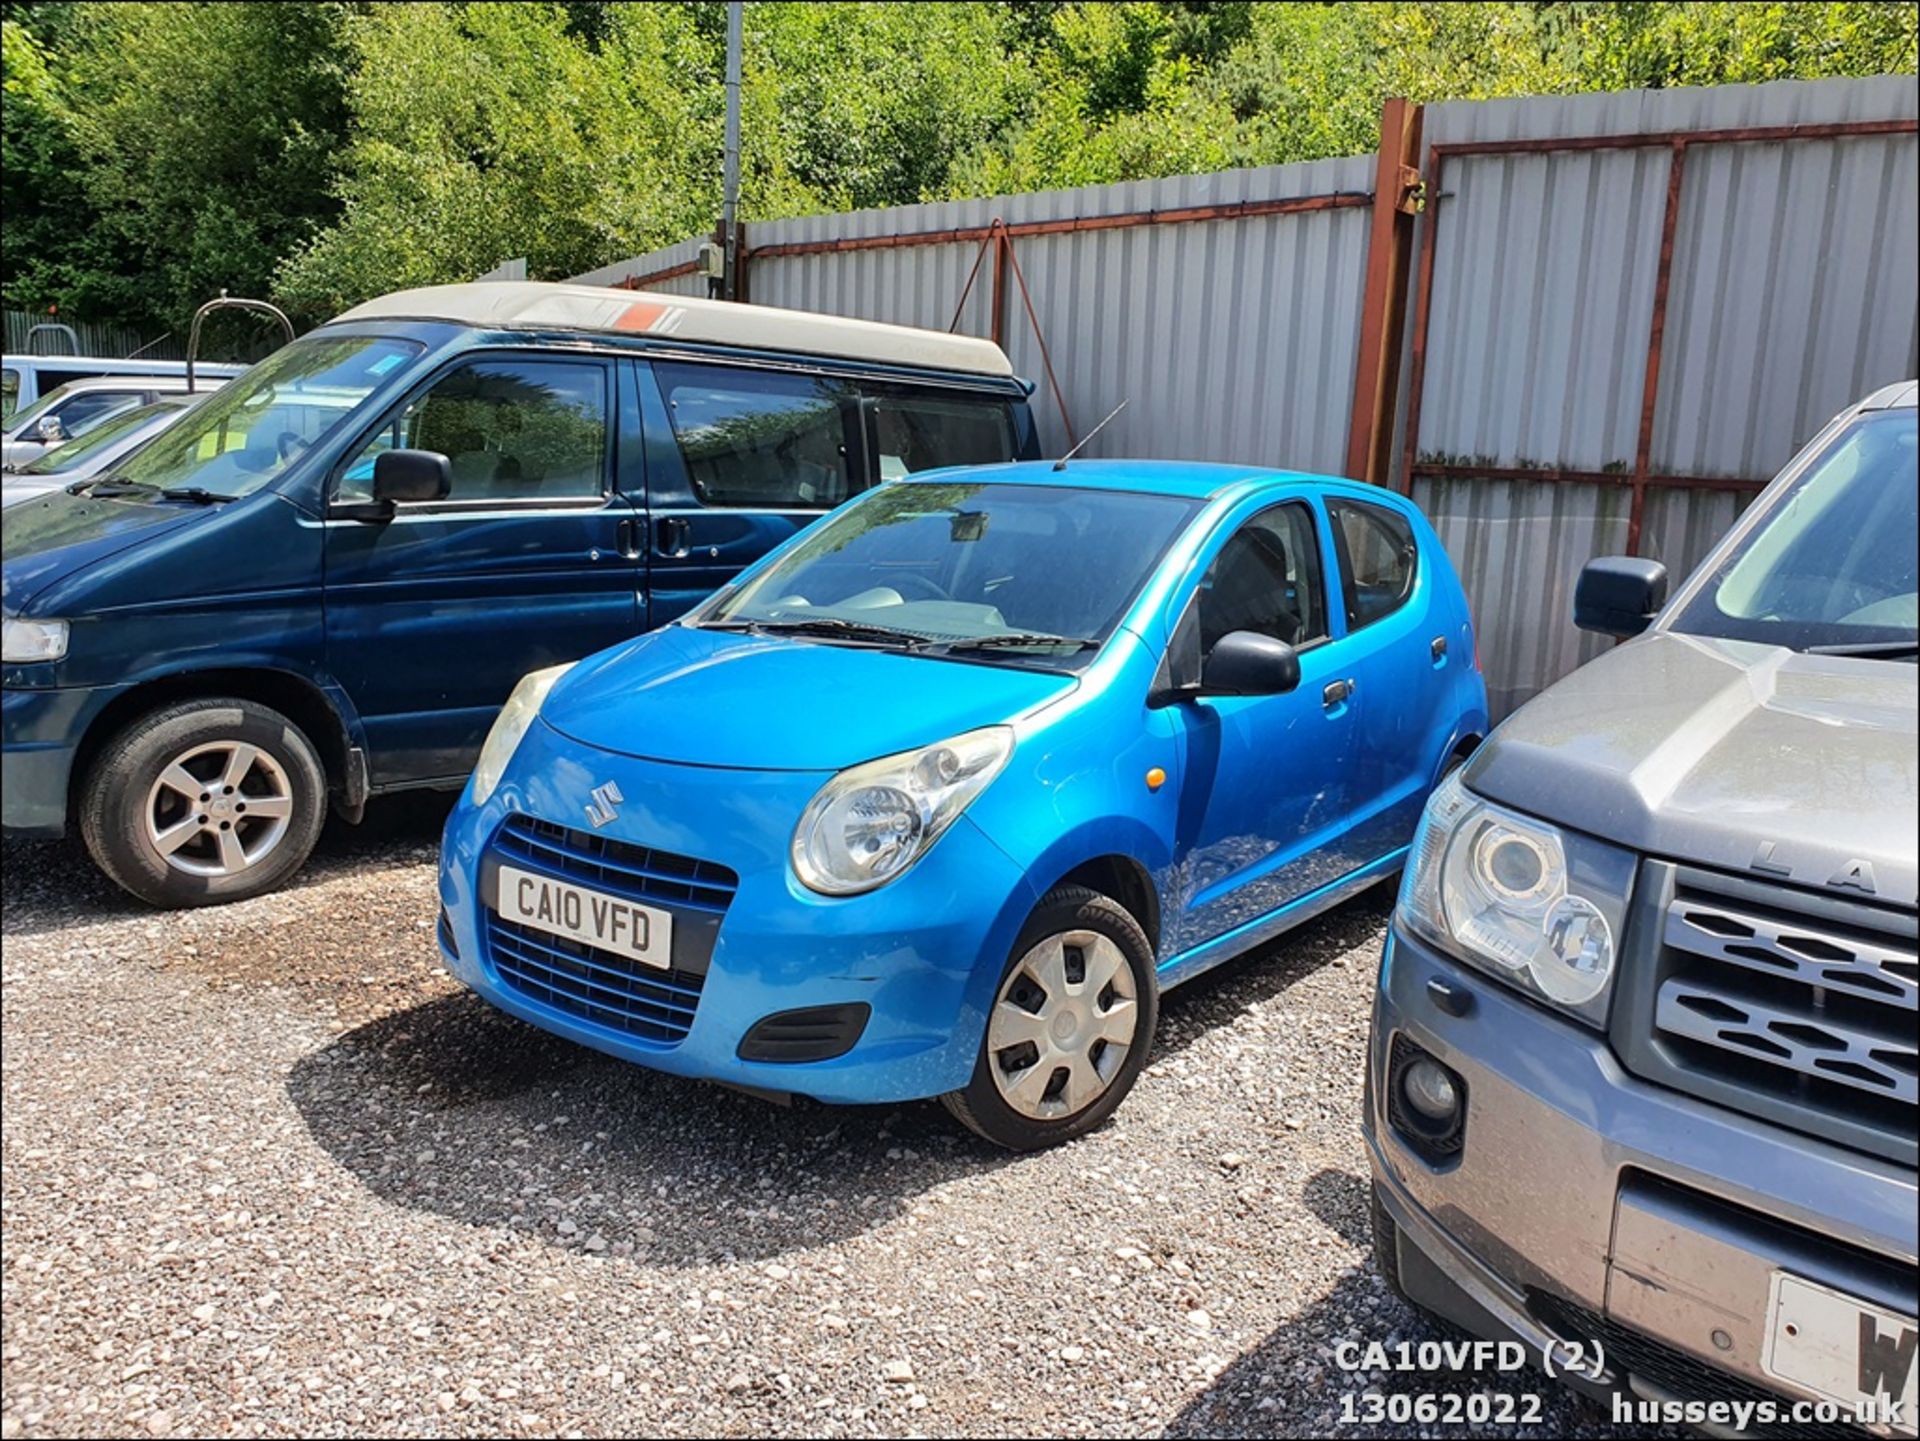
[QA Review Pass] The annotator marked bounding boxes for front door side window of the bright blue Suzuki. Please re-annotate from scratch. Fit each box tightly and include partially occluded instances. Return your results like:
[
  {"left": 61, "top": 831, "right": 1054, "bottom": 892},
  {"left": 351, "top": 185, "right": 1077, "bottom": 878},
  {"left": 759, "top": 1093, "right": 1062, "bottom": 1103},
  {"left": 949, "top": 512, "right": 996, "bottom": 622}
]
[{"left": 1198, "top": 505, "right": 1327, "bottom": 654}]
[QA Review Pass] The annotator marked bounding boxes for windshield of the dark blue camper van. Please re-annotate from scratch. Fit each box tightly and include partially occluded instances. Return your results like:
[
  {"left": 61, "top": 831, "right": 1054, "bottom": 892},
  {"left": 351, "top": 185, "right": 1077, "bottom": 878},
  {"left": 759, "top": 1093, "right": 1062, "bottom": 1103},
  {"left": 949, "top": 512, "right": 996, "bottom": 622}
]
[{"left": 113, "top": 336, "right": 426, "bottom": 495}]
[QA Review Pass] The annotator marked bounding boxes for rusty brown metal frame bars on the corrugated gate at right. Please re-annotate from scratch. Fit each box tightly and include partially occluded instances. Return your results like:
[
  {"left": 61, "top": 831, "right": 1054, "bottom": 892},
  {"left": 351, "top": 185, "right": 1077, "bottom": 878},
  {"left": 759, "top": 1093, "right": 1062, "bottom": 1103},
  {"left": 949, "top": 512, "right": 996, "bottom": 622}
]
[{"left": 1400, "top": 112, "right": 1920, "bottom": 555}]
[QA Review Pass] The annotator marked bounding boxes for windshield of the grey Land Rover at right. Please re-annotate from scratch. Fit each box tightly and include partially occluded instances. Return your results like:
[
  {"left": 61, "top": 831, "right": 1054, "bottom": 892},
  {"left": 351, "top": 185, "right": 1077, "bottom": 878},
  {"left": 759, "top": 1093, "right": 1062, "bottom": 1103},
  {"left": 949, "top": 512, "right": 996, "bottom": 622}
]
[{"left": 1672, "top": 407, "right": 1920, "bottom": 660}]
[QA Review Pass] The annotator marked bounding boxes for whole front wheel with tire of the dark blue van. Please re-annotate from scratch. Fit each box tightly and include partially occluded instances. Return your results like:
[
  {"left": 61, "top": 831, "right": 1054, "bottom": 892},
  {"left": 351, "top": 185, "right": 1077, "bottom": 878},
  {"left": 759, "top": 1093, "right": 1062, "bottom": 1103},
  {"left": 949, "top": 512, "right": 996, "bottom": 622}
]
[{"left": 79, "top": 697, "right": 326, "bottom": 908}]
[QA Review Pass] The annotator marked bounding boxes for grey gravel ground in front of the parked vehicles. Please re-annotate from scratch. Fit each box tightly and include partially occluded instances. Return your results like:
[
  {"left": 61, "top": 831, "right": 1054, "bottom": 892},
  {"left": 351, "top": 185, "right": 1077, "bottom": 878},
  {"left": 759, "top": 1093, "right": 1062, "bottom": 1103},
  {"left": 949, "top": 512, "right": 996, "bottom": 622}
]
[{"left": 0, "top": 804, "right": 1615, "bottom": 1437}]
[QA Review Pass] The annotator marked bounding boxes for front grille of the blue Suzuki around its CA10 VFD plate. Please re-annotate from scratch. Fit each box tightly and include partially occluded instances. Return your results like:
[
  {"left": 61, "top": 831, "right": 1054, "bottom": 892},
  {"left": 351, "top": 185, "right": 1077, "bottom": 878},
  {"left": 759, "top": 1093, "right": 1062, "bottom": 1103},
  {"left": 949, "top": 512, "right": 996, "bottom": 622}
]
[{"left": 486, "top": 815, "right": 739, "bottom": 1048}]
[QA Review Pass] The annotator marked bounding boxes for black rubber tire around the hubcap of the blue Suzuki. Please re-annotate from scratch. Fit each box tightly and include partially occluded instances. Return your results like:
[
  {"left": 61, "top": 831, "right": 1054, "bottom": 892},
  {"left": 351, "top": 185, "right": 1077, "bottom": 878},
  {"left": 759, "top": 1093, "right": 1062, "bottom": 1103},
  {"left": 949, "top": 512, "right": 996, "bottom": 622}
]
[{"left": 941, "top": 886, "right": 1160, "bottom": 1151}]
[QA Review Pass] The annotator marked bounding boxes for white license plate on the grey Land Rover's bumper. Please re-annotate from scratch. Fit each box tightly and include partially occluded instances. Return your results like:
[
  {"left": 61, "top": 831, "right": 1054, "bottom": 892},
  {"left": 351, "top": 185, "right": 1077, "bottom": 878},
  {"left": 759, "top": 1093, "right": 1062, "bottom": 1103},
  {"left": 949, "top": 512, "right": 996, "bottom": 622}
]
[{"left": 1761, "top": 1270, "right": 1920, "bottom": 1428}]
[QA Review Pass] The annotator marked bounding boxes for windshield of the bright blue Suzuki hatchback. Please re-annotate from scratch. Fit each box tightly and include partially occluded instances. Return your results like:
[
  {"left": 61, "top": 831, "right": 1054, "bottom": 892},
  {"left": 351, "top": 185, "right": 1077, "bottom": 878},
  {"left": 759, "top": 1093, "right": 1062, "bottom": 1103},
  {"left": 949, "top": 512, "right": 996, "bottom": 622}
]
[{"left": 693, "top": 480, "right": 1200, "bottom": 668}]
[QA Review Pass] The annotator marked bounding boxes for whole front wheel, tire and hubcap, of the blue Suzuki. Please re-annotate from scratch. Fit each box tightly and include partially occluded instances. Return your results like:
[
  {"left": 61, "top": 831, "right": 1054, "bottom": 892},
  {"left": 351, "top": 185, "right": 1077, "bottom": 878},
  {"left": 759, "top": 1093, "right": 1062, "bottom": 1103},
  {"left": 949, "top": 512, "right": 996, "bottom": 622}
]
[{"left": 941, "top": 886, "right": 1160, "bottom": 1151}]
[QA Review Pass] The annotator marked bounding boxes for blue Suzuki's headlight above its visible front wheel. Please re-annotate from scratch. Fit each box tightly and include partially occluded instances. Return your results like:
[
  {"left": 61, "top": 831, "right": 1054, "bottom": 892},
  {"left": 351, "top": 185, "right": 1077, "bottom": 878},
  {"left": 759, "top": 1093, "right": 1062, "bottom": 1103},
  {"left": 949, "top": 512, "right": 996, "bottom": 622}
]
[{"left": 793, "top": 725, "right": 1014, "bottom": 896}]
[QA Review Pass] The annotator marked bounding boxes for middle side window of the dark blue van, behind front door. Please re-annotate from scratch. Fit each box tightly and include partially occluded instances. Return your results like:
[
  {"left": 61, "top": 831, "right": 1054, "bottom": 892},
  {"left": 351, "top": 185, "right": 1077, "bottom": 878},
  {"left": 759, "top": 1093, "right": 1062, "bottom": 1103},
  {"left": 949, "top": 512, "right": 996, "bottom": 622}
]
[{"left": 653, "top": 363, "right": 852, "bottom": 510}]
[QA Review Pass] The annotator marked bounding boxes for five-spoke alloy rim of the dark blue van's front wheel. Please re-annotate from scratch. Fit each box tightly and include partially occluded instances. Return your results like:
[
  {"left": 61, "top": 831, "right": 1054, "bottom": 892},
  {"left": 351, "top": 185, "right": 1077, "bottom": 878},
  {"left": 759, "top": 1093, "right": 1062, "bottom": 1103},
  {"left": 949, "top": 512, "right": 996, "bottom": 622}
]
[{"left": 146, "top": 741, "right": 294, "bottom": 875}]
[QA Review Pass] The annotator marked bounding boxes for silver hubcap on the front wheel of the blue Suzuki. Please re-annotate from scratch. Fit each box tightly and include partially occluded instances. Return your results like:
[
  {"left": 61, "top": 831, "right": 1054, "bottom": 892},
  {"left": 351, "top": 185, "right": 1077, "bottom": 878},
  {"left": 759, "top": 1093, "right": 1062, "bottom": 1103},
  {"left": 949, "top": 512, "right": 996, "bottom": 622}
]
[{"left": 987, "top": 931, "right": 1139, "bottom": 1121}]
